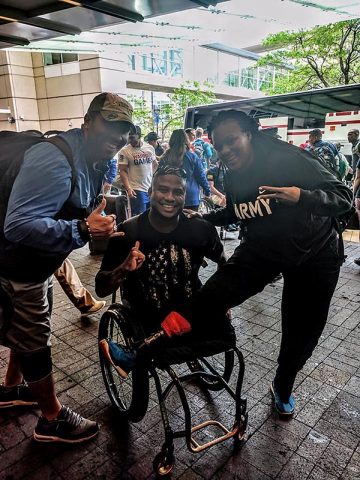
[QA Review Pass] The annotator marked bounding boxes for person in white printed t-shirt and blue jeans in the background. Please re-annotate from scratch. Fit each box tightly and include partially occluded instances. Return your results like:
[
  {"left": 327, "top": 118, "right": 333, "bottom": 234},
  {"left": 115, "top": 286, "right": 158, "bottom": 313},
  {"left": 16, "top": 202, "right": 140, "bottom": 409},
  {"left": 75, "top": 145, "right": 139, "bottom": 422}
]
[{"left": 119, "top": 126, "right": 157, "bottom": 216}]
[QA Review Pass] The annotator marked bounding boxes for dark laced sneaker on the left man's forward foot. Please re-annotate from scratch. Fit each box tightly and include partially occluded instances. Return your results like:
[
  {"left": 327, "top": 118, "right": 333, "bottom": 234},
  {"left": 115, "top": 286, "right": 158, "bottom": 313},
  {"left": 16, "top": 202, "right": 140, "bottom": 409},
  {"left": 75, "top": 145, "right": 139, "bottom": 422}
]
[{"left": 33, "top": 406, "right": 100, "bottom": 443}]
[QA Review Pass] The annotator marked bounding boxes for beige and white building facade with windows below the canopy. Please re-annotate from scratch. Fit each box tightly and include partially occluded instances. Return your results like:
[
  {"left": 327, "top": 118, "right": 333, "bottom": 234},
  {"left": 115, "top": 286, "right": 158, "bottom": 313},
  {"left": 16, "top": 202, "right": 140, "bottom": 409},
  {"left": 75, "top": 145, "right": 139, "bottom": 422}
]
[{"left": 0, "top": 46, "right": 284, "bottom": 132}]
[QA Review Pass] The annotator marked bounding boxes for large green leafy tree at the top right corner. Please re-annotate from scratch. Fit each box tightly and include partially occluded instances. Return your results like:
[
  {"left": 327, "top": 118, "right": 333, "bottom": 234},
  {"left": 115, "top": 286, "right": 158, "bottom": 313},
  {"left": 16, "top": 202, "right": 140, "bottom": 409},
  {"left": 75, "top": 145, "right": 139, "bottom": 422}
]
[{"left": 258, "top": 19, "right": 360, "bottom": 94}]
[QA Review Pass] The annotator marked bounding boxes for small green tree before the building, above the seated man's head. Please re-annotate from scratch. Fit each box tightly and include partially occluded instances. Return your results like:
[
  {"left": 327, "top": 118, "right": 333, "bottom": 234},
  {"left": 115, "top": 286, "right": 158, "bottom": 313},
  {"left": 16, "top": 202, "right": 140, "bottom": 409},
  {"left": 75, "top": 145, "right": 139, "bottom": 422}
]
[{"left": 160, "top": 81, "right": 216, "bottom": 138}]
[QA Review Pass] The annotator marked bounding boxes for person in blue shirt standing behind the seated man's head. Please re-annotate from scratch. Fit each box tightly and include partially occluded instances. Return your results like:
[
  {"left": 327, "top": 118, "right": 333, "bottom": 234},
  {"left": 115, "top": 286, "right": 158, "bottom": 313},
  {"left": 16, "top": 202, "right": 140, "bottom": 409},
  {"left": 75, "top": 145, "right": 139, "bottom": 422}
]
[{"left": 159, "top": 129, "right": 210, "bottom": 211}]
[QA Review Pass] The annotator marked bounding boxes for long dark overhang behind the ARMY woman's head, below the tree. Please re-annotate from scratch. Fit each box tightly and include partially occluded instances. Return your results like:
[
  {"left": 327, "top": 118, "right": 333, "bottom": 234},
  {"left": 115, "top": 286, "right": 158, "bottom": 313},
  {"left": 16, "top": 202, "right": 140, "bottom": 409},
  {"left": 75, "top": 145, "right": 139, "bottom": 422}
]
[{"left": 187, "top": 83, "right": 360, "bottom": 126}]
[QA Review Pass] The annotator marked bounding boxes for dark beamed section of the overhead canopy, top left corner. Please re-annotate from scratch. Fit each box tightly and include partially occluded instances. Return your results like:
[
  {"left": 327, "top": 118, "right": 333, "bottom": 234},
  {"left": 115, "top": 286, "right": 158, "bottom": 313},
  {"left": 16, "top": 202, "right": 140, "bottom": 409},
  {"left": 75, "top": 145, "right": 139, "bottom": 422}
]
[{"left": 0, "top": 0, "right": 221, "bottom": 49}]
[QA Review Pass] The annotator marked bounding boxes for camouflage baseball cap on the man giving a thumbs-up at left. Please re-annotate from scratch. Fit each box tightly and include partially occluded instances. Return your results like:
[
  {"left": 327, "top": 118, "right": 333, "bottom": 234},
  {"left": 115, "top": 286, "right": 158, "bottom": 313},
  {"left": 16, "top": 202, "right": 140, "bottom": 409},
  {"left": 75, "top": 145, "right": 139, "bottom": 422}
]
[{"left": 87, "top": 92, "right": 134, "bottom": 128}]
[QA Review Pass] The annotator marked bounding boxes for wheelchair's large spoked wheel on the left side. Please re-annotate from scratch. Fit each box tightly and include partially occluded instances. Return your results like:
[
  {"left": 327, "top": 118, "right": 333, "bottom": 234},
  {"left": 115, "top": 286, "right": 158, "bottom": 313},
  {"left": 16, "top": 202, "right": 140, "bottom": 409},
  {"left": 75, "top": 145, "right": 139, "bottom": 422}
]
[{"left": 98, "top": 304, "right": 149, "bottom": 422}]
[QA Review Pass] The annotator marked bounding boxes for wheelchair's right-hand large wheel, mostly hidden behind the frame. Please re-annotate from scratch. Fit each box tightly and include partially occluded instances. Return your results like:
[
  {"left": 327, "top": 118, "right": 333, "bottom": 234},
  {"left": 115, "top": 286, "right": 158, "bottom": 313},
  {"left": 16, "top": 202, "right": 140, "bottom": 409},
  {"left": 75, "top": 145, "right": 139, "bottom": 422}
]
[{"left": 187, "top": 350, "right": 234, "bottom": 391}]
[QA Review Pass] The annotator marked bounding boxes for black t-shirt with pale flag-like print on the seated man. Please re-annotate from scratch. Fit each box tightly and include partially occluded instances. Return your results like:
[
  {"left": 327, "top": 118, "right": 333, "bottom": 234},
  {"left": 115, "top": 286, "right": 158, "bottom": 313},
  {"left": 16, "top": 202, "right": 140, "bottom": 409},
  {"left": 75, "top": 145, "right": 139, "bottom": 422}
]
[{"left": 97, "top": 212, "right": 223, "bottom": 332}]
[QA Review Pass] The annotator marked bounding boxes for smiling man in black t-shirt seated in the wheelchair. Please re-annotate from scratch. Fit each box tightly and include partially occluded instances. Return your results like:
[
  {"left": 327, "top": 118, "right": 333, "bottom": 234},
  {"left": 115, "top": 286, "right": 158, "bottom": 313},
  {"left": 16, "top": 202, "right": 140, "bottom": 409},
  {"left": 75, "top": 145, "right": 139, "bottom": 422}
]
[{"left": 95, "top": 165, "right": 235, "bottom": 378}]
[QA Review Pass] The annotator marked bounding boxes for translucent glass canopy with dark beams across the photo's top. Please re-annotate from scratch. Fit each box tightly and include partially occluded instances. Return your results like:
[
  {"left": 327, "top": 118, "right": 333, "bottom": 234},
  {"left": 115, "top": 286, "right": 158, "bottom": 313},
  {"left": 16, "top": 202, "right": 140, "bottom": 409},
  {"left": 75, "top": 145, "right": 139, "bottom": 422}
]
[{"left": 0, "top": 0, "right": 360, "bottom": 54}]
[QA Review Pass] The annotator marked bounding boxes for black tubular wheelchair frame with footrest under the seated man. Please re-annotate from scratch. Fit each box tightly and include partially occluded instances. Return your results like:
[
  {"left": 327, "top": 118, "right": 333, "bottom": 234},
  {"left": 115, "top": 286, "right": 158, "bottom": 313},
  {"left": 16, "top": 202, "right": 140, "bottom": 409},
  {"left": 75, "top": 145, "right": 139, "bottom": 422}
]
[{"left": 99, "top": 295, "right": 248, "bottom": 476}]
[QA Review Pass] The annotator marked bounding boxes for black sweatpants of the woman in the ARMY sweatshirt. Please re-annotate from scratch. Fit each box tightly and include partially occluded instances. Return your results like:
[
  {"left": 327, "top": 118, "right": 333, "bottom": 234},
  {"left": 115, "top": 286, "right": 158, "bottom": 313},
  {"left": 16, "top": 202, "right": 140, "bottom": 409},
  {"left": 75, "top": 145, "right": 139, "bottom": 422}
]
[{"left": 188, "top": 239, "right": 340, "bottom": 401}]
